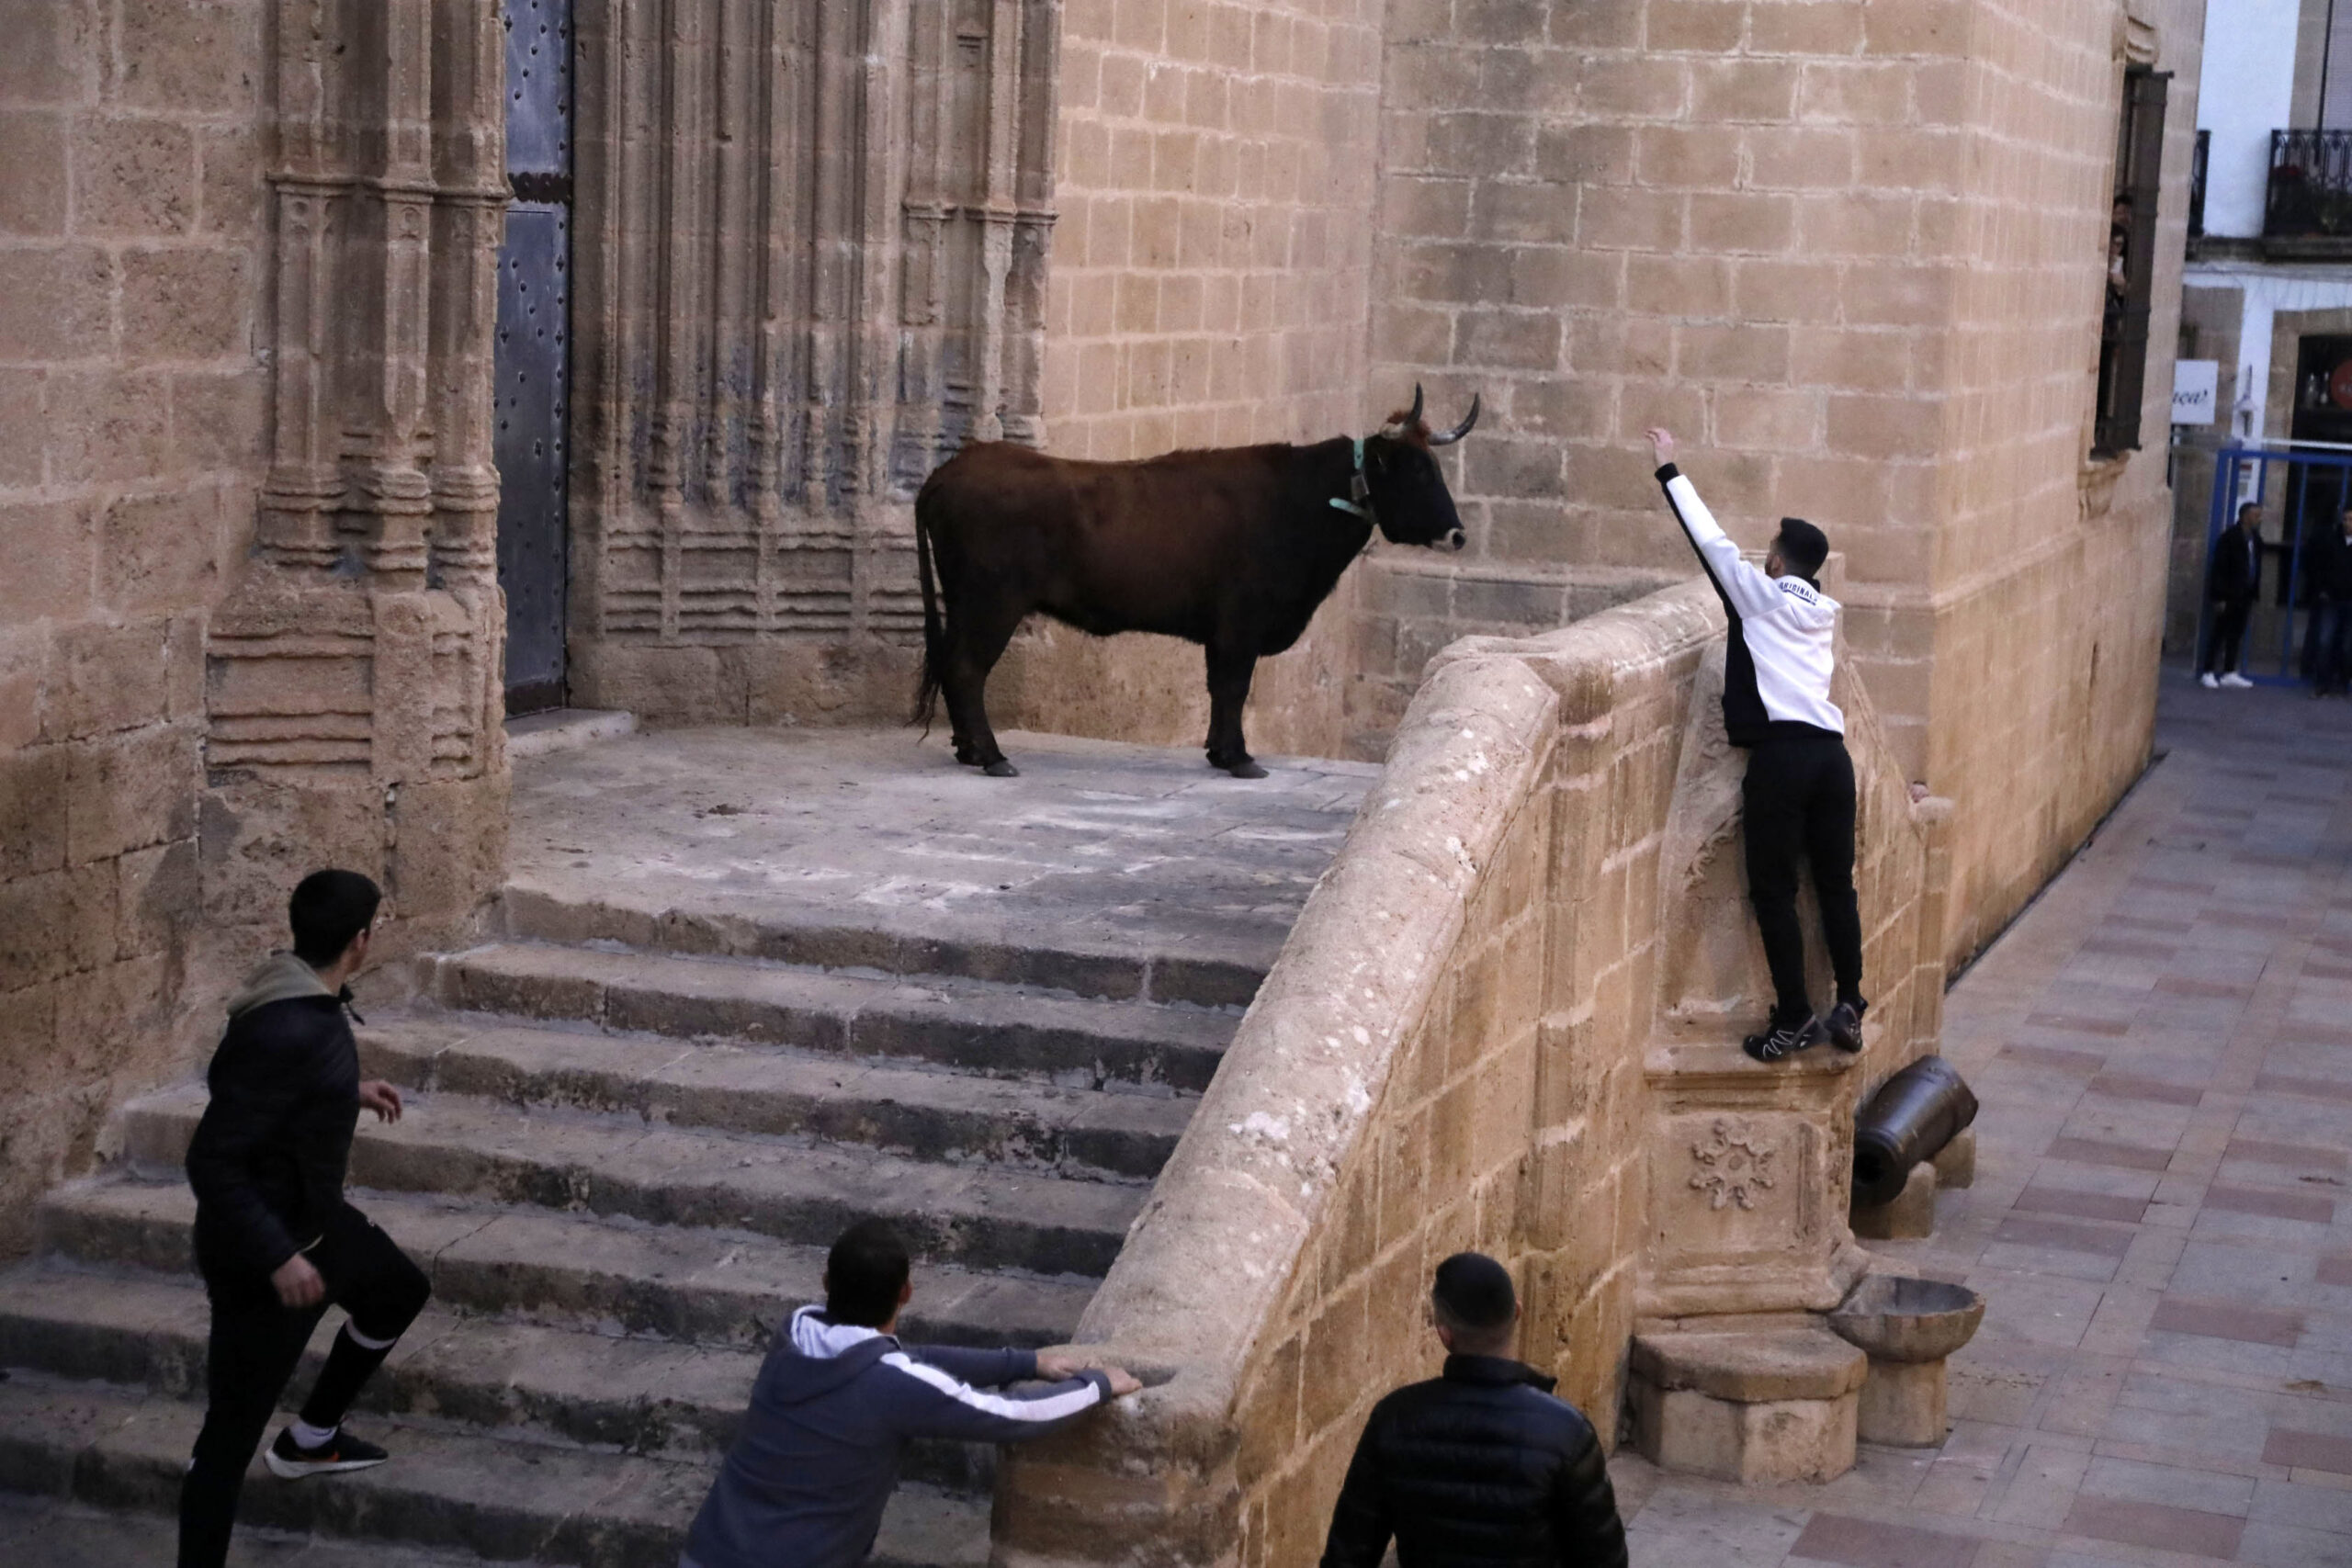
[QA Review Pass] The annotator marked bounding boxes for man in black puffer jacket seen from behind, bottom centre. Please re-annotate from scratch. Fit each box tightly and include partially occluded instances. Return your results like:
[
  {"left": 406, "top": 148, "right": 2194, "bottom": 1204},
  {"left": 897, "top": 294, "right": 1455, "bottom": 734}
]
[{"left": 1322, "top": 1253, "right": 1625, "bottom": 1568}]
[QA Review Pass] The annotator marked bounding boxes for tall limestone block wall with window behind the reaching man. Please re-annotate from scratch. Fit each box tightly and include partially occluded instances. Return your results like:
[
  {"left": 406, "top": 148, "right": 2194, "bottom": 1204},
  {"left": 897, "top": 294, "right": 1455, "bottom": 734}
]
[{"left": 1371, "top": 0, "right": 2201, "bottom": 954}]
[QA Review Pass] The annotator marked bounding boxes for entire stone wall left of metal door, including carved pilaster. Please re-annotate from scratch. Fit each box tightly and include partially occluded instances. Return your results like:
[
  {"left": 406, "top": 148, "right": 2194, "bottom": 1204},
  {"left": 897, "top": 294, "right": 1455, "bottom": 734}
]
[{"left": 0, "top": 0, "right": 505, "bottom": 1253}]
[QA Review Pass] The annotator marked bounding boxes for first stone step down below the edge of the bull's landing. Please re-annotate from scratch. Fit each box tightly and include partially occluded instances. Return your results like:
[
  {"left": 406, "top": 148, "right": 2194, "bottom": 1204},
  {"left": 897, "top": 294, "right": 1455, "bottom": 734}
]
[{"left": 433, "top": 942, "right": 1239, "bottom": 1093}]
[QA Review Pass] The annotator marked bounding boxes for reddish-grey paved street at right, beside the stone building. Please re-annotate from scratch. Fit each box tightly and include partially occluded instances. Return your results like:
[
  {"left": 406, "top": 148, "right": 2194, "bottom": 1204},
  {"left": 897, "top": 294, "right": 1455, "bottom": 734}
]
[{"left": 1613, "top": 668, "right": 2352, "bottom": 1568}]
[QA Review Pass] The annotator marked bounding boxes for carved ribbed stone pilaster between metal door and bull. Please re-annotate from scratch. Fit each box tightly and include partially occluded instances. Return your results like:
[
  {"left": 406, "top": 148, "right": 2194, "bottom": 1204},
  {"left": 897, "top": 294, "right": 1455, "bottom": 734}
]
[{"left": 571, "top": 0, "right": 1056, "bottom": 719}]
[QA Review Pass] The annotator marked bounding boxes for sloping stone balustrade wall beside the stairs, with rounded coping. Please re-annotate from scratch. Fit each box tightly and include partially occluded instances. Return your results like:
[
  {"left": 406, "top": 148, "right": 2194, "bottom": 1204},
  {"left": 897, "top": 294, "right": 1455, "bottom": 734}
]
[{"left": 992, "top": 583, "right": 1943, "bottom": 1568}]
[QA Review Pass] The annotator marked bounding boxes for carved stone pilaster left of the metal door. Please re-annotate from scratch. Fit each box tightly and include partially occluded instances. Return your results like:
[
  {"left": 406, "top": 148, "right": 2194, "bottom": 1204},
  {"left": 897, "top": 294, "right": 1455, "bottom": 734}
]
[{"left": 205, "top": 0, "right": 505, "bottom": 947}]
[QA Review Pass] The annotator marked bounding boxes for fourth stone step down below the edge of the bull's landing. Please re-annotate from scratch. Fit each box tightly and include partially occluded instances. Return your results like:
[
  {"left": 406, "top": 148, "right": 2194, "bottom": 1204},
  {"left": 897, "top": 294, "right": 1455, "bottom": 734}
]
[{"left": 40, "top": 1178, "right": 1093, "bottom": 1349}]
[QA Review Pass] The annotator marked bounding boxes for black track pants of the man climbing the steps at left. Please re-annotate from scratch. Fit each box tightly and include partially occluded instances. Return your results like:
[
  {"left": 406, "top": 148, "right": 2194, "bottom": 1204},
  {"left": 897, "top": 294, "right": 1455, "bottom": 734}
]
[{"left": 179, "top": 1206, "right": 433, "bottom": 1568}]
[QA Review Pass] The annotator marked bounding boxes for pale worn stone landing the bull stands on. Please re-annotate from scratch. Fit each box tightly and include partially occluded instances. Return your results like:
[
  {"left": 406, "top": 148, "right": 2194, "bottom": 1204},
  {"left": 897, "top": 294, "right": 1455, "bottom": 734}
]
[{"left": 508, "top": 728, "right": 1378, "bottom": 1001}]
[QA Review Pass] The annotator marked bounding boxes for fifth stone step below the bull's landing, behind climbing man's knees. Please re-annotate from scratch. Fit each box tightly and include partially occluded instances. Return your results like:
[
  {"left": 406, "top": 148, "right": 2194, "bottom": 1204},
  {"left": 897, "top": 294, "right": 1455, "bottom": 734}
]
[{"left": 0, "top": 1262, "right": 995, "bottom": 1493}]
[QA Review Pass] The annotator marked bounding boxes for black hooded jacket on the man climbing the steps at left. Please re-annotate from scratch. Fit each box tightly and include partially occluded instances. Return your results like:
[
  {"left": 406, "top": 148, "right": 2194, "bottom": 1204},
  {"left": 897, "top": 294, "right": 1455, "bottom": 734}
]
[{"left": 188, "top": 952, "right": 360, "bottom": 1277}]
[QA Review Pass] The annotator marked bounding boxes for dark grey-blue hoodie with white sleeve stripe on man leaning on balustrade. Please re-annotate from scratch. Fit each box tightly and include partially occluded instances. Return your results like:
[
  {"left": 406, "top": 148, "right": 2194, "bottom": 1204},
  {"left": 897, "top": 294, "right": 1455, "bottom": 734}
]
[{"left": 680, "top": 1307, "right": 1110, "bottom": 1568}]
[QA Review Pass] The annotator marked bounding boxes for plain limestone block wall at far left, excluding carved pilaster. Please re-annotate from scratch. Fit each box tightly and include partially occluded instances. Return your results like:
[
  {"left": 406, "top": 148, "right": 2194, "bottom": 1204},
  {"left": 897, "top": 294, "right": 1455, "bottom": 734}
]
[{"left": 0, "top": 0, "right": 268, "bottom": 1256}]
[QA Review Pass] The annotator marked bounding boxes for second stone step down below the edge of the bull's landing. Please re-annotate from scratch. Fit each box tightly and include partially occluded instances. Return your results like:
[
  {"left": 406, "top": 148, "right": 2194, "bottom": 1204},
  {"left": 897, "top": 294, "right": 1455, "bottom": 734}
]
[{"left": 360, "top": 1013, "right": 1197, "bottom": 1180}]
